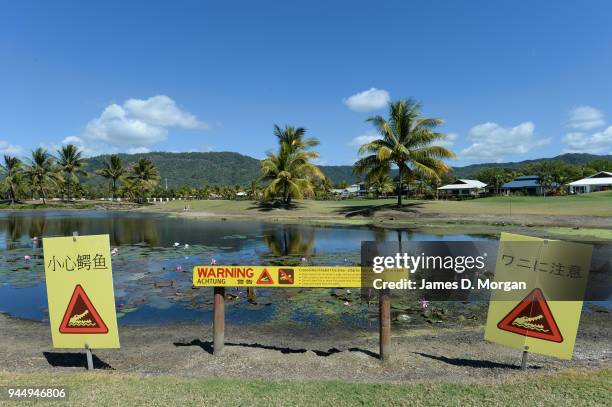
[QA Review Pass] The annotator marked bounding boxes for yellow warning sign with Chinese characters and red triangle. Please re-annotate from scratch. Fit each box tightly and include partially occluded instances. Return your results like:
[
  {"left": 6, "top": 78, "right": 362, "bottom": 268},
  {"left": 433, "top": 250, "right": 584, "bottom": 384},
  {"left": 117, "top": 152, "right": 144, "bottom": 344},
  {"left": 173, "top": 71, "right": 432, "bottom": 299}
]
[{"left": 43, "top": 235, "right": 119, "bottom": 349}]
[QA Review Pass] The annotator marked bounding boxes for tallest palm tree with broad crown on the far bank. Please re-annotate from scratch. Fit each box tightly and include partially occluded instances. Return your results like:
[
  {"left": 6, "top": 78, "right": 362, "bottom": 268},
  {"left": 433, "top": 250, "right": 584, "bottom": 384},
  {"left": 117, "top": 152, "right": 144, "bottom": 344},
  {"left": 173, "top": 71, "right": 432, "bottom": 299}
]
[{"left": 354, "top": 99, "right": 455, "bottom": 206}]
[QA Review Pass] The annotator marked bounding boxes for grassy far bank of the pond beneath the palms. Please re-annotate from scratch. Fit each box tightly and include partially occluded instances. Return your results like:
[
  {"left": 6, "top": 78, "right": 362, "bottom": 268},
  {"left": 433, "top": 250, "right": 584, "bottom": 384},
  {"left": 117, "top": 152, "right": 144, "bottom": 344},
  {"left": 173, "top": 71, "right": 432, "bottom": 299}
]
[{"left": 0, "top": 197, "right": 612, "bottom": 240}]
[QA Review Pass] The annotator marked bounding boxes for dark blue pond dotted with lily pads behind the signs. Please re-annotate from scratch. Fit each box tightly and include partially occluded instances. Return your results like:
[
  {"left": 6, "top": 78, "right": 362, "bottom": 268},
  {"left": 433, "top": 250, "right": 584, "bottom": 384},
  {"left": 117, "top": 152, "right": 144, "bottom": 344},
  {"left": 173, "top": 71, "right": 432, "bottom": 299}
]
[{"left": 0, "top": 211, "right": 604, "bottom": 328}]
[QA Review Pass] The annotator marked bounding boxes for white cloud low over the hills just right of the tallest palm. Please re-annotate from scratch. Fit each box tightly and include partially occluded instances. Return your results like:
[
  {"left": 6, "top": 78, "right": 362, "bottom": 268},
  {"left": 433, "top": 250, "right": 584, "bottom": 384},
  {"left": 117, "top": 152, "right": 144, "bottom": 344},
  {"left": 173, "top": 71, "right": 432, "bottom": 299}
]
[{"left": 458, "top": 122, "right": 551, "bottom": 162}]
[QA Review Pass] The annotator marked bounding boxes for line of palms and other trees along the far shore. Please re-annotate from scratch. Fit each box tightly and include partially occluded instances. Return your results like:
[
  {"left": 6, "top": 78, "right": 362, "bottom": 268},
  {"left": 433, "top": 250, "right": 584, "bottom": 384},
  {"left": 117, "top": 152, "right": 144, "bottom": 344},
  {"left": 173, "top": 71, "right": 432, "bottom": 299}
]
[{"left": 0, "top": 99, "right": 612, "bottom": 206}]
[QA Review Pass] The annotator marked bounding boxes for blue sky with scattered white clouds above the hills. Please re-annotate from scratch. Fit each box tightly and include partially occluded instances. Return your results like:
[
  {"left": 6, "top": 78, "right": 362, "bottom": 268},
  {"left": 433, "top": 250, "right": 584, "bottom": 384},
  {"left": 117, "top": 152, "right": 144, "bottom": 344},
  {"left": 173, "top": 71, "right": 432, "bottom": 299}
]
[{"left": 0, "top": 0, "right": 612, "bottom": 165}]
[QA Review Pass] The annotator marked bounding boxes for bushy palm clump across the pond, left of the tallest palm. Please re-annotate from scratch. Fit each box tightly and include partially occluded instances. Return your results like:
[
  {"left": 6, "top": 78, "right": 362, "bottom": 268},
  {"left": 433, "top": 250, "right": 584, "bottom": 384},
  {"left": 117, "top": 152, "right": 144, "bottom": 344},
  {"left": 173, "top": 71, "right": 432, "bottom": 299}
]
[{"left": 261, "top": 125, "right": 325, "bottom": 206}]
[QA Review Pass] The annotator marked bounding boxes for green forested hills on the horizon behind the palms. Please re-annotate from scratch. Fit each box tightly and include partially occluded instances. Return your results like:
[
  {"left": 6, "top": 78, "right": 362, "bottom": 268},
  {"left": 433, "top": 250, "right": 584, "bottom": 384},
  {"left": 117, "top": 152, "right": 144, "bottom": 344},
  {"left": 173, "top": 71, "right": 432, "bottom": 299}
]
[{"left": 87, "top": 152, "right": 612, "bottom": 188}]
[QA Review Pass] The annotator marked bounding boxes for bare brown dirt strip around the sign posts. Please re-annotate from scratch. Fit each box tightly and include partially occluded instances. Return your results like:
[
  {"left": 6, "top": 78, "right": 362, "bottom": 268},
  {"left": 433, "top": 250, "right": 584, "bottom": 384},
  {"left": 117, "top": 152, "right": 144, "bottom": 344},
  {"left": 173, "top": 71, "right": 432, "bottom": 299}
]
[{"left": 0, "top": 311, "right": 612, "bottom": 382}]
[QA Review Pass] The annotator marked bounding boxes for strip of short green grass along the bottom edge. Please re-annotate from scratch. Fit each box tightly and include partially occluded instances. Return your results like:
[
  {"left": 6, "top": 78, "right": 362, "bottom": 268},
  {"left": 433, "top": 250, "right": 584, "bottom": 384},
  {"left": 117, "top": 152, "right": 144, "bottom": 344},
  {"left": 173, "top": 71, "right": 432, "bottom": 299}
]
[{"left": 0, "top": 369, "right": 612, "bottom": 406}]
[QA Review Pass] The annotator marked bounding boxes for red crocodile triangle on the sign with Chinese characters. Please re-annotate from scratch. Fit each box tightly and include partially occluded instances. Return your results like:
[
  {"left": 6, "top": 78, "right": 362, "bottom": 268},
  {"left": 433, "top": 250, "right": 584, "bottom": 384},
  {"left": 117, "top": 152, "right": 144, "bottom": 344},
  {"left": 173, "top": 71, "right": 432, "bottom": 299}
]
[{"left": 60, "top": 284, "right": 108, "bottom": 334}]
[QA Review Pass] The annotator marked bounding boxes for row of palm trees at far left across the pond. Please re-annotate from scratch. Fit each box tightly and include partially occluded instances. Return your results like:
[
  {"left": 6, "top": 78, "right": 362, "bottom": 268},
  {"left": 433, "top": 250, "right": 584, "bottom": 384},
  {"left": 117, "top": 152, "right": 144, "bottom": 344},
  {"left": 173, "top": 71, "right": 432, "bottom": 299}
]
[{"left": 0, "top": 144, "right": 159, "bottom": 205}]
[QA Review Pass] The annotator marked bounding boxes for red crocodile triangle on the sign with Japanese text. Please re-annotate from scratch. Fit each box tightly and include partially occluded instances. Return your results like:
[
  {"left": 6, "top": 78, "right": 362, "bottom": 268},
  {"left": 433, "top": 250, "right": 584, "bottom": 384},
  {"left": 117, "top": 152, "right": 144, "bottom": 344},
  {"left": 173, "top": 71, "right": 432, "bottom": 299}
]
[{"left": 497, "top": 288, "right": 563, "bottom": 342}]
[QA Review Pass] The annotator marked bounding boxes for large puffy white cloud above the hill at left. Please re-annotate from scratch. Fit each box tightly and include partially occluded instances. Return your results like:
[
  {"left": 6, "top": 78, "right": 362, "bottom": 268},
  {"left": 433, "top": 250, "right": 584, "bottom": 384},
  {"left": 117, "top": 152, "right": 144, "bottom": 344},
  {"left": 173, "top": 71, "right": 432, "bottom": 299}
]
[{"left": 81, "top": 95, "right": 207, "bottom": 149}]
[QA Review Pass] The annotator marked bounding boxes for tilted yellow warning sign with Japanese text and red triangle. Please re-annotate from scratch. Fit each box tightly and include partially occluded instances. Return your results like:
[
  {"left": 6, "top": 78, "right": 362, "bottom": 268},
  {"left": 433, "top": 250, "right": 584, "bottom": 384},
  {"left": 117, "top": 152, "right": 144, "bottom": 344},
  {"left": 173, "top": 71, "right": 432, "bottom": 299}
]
[{"left": 485, "top": 233, "right": 593, "bottom": 359}]
